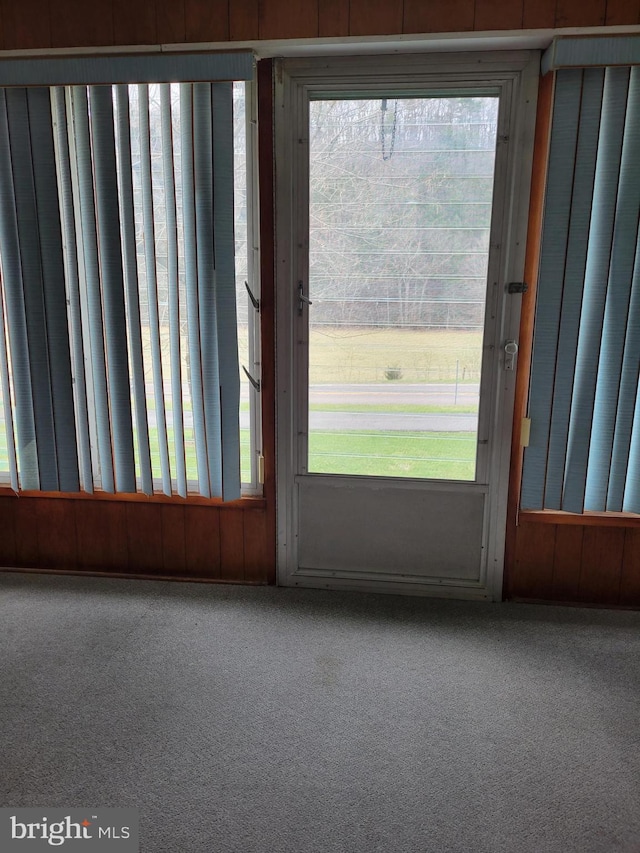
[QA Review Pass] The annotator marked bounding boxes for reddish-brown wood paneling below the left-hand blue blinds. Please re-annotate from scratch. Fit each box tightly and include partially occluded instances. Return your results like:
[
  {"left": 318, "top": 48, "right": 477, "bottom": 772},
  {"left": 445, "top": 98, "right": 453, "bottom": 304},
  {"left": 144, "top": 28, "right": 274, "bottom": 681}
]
[{"left": 0, "top": 496, "right": 275, "bottom": 583}]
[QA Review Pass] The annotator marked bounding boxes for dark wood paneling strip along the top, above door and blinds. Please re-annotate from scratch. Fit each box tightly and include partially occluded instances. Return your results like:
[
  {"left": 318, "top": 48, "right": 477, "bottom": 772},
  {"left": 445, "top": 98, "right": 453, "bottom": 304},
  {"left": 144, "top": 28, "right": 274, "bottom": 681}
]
[{"left": 0, "top": 0, "right": 640, "bottom": 50}]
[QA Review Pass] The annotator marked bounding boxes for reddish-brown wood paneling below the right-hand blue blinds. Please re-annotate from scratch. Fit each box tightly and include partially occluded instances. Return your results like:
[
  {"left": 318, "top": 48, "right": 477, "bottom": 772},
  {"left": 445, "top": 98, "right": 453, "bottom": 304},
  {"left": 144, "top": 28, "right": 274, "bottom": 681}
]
[{"left": 506, "top": 513, "right": 640, "bottom": 607}]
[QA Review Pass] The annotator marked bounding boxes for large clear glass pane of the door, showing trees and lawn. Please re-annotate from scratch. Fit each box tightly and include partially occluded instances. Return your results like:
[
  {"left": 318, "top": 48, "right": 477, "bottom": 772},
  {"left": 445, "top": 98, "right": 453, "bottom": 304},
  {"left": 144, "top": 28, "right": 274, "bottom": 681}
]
[{"left": 308, "top": 97, "right": 498, "bottom": 480}]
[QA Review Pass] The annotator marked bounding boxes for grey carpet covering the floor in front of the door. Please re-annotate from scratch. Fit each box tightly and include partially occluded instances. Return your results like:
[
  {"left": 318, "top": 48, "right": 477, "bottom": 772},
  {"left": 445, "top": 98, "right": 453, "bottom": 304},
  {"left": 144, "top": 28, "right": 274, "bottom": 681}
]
[{"left": 0, "top": 574, "right": 640, "bottom": 853}]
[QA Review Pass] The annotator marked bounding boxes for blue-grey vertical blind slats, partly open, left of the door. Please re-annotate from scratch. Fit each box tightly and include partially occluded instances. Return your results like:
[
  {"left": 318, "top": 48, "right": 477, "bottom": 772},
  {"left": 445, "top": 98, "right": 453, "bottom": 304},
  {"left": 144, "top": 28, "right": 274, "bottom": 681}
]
[{"left": 0, "top": 70, "right": 249, "bottom": 500}]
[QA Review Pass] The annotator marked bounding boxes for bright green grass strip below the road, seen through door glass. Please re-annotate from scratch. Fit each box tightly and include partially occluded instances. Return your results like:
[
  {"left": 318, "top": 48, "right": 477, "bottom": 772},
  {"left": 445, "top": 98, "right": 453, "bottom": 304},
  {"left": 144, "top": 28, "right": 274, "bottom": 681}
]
[{"left": 309, "top": 432, "right": 476, "bottom": 480}]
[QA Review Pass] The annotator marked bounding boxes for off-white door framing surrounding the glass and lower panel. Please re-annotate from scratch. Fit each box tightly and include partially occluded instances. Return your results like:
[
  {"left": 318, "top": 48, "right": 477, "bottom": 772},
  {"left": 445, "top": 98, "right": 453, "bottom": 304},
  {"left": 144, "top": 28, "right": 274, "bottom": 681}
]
[{"left": 274, "top": 51, "right": 540, "bottom": 600}]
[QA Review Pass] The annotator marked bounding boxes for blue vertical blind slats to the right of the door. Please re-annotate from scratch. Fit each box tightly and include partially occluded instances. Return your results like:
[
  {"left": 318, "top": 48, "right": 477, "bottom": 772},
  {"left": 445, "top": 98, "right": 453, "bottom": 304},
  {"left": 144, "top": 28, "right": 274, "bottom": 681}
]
[{"left": 521, "top": 67, "right": 640, "bottom": 513}]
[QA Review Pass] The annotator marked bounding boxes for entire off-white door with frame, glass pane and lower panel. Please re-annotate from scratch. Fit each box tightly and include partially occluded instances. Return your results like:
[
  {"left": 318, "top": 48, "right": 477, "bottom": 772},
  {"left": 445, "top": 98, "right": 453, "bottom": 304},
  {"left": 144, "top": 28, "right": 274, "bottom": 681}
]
[{"left": 276, "top": 53, "right": 537, "bottom": 598}]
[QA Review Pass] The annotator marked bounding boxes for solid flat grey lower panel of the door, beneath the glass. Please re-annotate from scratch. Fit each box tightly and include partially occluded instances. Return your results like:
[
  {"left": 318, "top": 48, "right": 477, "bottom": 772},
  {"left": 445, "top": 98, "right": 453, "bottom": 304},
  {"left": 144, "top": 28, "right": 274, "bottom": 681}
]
[{"left": 298, "top": 476, "right": 486, "bottom": 583}]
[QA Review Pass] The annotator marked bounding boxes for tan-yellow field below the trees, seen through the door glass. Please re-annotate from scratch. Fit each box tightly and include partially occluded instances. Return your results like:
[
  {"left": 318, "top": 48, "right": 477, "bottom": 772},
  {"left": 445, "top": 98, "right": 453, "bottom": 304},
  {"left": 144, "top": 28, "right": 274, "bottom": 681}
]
[{"left": 309, "top": 326, "right": 482, "bottom": 384}]
